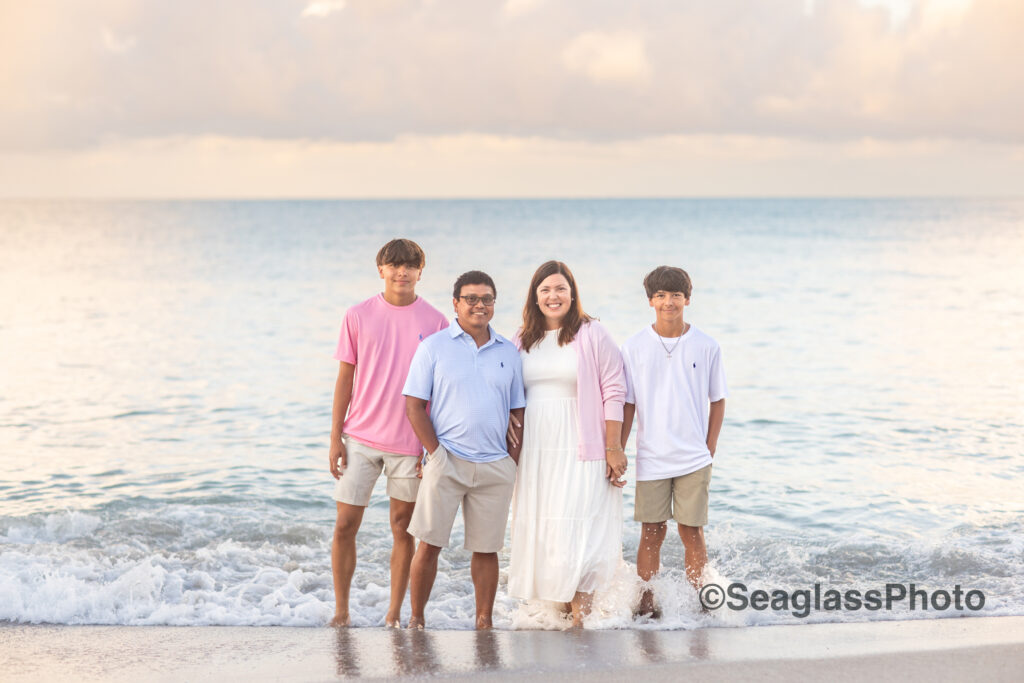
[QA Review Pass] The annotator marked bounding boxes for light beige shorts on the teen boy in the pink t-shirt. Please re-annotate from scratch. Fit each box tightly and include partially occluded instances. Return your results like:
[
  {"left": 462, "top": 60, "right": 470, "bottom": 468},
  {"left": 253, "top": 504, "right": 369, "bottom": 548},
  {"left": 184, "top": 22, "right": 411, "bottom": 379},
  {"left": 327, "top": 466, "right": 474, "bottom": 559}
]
[{"left": 334, "top": 436, "right": 420, "bottom": 507}]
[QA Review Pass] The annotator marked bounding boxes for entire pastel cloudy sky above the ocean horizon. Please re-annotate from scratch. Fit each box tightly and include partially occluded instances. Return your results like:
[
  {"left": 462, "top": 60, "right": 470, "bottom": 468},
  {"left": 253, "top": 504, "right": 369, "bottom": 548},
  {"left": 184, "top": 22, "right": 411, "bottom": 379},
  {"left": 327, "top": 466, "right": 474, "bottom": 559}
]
[{"left": 0, "top": 0, "right": 1024, "bottom": 198}]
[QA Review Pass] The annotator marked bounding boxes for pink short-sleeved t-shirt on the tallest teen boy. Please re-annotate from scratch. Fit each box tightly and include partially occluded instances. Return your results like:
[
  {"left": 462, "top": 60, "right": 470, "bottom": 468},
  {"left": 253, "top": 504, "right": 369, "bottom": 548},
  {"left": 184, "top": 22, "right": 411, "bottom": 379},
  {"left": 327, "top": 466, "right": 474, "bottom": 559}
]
[{"left": 334, "top": 294, "right": 447, "bottom": 456}]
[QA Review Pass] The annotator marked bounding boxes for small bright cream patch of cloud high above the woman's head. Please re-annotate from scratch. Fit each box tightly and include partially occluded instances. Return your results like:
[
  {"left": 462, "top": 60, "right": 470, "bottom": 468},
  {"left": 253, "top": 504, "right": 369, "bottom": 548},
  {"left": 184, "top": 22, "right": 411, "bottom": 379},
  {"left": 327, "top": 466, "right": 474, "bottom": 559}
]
[{"left": 562, "top": 32, "right": 651, "bottom": 85}]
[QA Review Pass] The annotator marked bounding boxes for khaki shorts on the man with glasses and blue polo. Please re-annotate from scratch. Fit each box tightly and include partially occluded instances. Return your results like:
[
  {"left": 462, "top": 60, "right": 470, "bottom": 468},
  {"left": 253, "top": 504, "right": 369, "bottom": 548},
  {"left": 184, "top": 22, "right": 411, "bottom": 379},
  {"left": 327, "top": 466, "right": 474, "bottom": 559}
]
[{"left": 409, "top": 445, "right": 516, "bottom": 553}]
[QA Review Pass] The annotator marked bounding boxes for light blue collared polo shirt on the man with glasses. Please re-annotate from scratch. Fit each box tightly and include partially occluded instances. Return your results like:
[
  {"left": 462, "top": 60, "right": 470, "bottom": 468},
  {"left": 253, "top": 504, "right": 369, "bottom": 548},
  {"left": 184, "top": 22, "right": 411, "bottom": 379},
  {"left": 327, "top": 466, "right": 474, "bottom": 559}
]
[{"left": 401, "top": 318, "right": 526, "bottom": 463}]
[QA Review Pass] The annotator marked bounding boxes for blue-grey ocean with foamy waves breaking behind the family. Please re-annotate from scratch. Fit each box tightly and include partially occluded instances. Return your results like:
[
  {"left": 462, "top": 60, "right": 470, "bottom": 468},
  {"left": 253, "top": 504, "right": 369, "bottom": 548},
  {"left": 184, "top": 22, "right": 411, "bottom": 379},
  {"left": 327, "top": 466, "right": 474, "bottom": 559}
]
[{"left": 0, "top": 200, "right": 1024, "bottom": 629}]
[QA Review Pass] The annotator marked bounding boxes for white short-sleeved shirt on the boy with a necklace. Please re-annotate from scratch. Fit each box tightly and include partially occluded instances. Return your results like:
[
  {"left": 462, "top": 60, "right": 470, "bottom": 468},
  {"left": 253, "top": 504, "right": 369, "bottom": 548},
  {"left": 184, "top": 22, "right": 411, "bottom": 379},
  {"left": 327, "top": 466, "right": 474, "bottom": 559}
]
[{"left": 623, "top": 325, "right": 728, "bottom": 481}]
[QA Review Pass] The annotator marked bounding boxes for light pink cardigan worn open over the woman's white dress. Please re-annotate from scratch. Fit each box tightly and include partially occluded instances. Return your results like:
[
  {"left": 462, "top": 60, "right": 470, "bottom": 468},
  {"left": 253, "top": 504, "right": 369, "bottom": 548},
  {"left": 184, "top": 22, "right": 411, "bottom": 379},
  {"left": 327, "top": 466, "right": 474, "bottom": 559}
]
[{"left": 512, "top": 321, "right": 626, "bottom": 460}]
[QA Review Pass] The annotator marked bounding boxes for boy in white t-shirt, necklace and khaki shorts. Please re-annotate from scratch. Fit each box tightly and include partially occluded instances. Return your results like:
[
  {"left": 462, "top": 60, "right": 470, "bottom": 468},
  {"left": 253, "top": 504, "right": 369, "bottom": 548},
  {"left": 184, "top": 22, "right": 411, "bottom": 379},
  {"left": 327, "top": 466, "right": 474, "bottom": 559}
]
[{"left": 623, "top": 265, "right": 728, "bottom": 616}]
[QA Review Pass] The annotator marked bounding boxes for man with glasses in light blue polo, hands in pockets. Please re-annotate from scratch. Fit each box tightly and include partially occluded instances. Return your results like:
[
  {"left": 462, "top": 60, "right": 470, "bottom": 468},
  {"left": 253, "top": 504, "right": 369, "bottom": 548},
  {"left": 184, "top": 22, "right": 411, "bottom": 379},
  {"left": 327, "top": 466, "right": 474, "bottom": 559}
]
[{"left": 402, "top": 270, "right": 526, "bottom": 629}]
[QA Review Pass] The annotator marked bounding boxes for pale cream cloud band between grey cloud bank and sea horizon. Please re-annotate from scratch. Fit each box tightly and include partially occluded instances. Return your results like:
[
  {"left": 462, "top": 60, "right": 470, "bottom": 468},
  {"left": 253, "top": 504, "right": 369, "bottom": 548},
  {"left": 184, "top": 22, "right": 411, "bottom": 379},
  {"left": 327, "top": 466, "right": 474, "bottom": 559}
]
[{"left": 0, "top": 134, "right": 1024, "bottom": 198}]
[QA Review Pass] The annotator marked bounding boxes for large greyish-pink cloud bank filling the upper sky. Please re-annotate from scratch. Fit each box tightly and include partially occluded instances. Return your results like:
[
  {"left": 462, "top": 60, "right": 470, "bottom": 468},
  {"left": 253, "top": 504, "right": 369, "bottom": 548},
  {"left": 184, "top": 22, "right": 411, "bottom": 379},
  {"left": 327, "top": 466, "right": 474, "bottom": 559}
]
[{"left": 0, "top": 0, "right": 1024, "bottom": 150}]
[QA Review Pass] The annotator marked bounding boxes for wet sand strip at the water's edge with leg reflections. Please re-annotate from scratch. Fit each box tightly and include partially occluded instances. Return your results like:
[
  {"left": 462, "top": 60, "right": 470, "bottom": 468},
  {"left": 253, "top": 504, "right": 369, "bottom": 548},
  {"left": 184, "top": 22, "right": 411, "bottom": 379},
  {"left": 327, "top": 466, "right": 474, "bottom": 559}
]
[{"left": 0, "top": 616, "right": 1024, "bottom": 682}]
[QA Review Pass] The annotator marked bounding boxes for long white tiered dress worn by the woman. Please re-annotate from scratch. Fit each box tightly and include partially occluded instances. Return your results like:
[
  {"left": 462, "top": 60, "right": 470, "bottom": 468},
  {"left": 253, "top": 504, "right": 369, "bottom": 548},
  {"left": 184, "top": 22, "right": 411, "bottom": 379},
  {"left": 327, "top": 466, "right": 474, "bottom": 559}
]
[{"left": 508, "top": 330, "right": 623, "bottom": 602}]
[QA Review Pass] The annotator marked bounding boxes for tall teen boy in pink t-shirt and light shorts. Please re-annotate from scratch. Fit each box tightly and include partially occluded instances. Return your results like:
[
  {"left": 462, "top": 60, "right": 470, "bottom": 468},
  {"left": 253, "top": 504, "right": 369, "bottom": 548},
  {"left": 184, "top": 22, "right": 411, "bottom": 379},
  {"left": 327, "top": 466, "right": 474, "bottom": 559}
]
[{"left": 330, "top": 240, "right": 447, "bottom": 628}]
